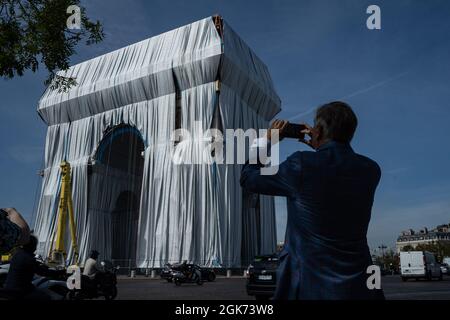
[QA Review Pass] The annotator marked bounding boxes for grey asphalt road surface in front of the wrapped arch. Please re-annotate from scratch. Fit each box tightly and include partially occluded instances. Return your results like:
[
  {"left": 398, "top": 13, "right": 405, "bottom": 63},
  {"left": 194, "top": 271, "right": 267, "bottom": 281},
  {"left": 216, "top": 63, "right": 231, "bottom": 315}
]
[{"left": 117, "top": 276, "right": 450, "bottom": 300}]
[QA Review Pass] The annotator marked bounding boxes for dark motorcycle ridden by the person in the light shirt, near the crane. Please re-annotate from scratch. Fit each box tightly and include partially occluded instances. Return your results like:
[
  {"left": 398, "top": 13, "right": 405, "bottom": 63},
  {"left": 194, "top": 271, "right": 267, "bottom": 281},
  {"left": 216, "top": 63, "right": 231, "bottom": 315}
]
[{"left": 68, "top": 261, "right": 119, "bottom": 300}]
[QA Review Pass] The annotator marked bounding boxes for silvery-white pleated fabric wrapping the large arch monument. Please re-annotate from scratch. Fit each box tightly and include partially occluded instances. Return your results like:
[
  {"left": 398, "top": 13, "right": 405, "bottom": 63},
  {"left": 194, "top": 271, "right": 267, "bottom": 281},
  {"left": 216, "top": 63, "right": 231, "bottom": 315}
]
[{"left": 35, "top": 17, "right": 280, "bottom": 268}]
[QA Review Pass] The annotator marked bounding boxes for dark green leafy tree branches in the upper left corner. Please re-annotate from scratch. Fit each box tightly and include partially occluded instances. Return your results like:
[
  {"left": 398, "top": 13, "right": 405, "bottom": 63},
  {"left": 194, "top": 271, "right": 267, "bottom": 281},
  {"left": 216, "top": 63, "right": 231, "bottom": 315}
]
[{"left": 0, "top": 0, "right": 104, "bottom": 90}]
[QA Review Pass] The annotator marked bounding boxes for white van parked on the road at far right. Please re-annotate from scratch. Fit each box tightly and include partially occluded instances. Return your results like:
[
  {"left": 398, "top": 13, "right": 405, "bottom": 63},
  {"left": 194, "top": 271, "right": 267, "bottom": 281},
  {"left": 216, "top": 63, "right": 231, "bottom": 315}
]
[{"left": 400, "top": 251, "right": 442, "bottom": 281}]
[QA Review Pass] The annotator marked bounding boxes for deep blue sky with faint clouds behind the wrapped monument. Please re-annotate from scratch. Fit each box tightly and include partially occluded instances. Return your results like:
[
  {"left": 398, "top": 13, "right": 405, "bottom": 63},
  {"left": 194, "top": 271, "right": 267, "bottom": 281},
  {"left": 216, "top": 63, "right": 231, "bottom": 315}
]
[{"left": 0, "top": 0, "right": 450, "bottom": 247}]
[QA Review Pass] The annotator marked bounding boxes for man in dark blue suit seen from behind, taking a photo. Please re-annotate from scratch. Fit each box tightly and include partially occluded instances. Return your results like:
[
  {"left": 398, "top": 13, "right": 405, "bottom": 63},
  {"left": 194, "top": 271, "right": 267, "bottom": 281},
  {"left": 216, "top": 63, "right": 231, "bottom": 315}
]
[{"left": 241, "top": 101, "right": 384, "bottom": 300}]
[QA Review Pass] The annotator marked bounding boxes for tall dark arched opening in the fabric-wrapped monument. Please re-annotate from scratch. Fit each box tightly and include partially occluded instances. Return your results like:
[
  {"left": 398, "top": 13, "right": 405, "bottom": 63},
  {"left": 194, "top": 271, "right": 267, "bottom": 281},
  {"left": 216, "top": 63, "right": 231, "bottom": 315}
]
[{"left": 88, "top": 125, "right": 145, "bottom": 266}]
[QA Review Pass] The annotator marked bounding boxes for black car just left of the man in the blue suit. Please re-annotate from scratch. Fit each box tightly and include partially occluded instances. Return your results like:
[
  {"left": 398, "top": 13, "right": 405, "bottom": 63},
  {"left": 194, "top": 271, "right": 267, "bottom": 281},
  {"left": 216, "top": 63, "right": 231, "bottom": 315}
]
[{"left": 247, "top": 254, "right": 279, "bottom": 300}]
